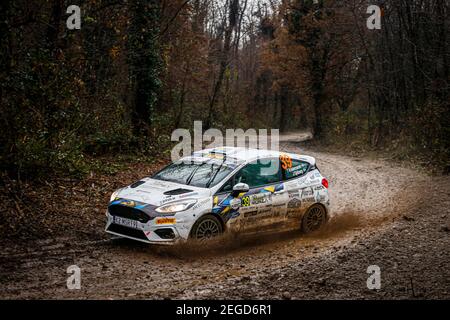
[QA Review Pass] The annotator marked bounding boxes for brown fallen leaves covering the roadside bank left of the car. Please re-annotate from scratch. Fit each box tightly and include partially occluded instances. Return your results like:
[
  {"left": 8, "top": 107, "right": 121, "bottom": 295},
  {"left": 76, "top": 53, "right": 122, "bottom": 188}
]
[{"left": 0, "top": 159, "right": 166, "bottom": 241}]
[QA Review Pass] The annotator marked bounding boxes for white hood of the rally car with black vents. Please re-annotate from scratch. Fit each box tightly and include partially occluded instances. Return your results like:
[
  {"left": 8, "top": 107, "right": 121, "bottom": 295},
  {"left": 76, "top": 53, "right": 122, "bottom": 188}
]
[{"left": 112, "top": 178, "right": 211, "bottom": 206}]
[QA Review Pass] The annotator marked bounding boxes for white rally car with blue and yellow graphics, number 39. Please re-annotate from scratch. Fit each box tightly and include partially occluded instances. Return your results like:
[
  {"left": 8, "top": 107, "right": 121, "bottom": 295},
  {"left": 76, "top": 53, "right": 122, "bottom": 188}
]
[{"left": 106, "top": 147, "right": 329, "bottom": 244}]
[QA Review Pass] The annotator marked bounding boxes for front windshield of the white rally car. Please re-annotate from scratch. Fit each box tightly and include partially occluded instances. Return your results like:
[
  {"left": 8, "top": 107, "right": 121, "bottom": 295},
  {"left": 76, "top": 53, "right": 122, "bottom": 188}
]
[{"left": 152, "top": 161, "right": 233, "bottom": 188}]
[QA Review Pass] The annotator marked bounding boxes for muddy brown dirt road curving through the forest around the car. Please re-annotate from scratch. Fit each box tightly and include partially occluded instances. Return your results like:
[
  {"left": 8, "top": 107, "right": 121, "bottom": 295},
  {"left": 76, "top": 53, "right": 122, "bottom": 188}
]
[{"left": 0, "top": 143, "right": 450, "bottom": 299}]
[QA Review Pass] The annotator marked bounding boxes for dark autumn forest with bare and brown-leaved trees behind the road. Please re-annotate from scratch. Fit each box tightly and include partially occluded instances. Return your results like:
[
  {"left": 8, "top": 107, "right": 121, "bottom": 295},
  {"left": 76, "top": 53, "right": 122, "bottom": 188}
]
[{"left": 0, "top": 0, "right": 450, "bottom": 180}]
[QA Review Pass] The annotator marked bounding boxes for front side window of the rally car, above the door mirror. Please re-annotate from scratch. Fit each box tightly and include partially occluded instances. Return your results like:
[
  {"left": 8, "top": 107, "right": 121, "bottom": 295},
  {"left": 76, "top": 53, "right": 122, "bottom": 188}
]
[{"left": 234, "top": 158, "right": 281, "bottom": 188}]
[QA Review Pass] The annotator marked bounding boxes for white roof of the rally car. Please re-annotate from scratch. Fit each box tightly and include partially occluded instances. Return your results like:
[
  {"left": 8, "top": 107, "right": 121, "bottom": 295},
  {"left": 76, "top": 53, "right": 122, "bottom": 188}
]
[{"left": 192, "top": 147, "right": 316, "bottom": 165}]
